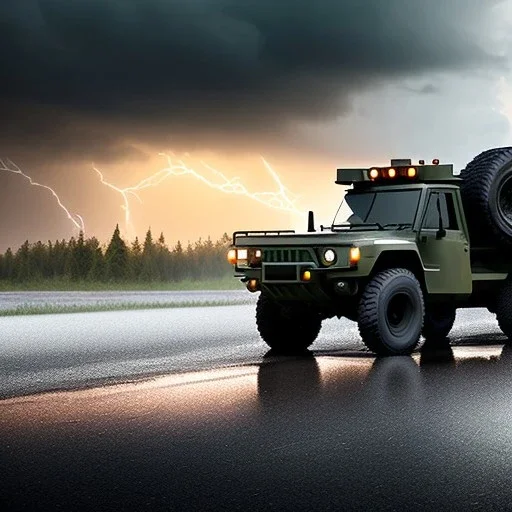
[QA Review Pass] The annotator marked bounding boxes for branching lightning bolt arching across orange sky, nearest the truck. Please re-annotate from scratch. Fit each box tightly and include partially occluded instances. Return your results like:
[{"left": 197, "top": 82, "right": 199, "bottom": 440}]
[{"left": 93, "top": 153, "right": 305, "bottom": 230}]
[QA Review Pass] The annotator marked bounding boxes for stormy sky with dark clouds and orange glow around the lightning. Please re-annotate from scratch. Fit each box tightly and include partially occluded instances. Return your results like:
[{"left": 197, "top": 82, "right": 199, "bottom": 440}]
[{"left": 0, "top": 0, "right": 512, "bottom": 250}]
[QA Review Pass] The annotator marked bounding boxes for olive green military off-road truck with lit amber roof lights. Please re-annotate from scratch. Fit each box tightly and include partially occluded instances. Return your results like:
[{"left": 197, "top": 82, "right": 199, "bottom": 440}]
[{"left": 228, "top": 147, "right": 512, "bottom": 356}]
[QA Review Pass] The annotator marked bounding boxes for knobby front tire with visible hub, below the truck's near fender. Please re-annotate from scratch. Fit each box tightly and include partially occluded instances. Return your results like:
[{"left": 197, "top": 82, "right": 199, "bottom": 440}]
[{"left": 358, "top": 268, "right": 425, "bottom": 356}]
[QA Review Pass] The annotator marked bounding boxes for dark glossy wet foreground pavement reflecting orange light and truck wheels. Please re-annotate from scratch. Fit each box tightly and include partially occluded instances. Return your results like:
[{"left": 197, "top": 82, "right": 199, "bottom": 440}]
[{"left": 0, "top": 340, "right": 512, "bottom": 511}]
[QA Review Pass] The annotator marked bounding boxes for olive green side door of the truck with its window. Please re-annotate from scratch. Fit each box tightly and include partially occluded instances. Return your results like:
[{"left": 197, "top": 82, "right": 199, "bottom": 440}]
[{"left": 418, "top": 189, "right": 472, "bottom": 294}]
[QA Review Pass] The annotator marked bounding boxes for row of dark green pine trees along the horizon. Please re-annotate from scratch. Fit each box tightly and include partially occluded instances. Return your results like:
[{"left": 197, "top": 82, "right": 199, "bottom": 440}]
[{"left": 0, "top": 226, "right": 232, "bottom": 283}]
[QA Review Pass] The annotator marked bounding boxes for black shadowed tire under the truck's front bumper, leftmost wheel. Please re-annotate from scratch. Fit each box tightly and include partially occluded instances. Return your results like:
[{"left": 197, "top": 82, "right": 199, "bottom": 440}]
[{"left": 256, "top": 293, "right": 322, "bottom": 355}]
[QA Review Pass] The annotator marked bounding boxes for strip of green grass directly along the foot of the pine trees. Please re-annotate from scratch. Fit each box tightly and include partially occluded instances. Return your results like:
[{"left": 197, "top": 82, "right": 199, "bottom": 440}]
[{"left": 0, "top": 276, "right": 245, "bottom": 292}]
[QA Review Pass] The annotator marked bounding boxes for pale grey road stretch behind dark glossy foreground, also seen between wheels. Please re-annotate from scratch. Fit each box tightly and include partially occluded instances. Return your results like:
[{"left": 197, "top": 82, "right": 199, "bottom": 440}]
[{"left": 0, "top": 305, "right": 504, "bottom": 398}]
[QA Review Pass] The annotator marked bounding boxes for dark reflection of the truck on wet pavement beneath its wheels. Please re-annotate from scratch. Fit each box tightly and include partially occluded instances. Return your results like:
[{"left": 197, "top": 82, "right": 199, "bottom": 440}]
[{"left": 258, "top": 343, "right": 512, "bottom": 410}]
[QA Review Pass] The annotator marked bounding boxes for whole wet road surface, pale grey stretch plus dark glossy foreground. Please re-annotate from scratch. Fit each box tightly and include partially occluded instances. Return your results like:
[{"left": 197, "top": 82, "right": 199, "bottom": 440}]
[{"left": 0, "top": 306, "right": 512, "bottom": 511}]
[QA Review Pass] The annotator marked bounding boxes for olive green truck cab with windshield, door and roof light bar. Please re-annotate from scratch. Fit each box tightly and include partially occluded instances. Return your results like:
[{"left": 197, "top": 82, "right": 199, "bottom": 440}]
[{"left": 336, "top": 160, "right": 472, "bottom": 296}]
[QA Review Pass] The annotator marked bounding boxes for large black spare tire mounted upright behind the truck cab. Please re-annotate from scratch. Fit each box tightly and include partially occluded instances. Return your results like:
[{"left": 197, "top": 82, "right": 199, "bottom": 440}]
[{"left": 460, "top": 147, "right": 512, "bottom": 247}]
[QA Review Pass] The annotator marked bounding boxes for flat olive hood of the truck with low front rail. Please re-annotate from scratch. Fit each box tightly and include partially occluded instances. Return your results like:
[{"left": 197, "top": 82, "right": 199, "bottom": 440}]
[{"left": 235, "top": 229, "right": 415, "bottom": 247}]
